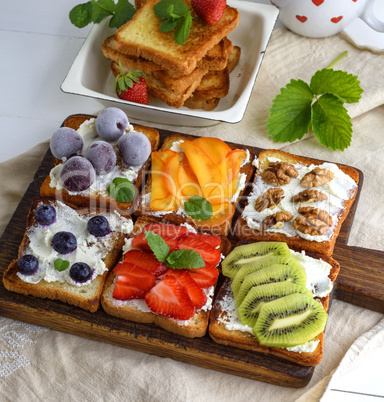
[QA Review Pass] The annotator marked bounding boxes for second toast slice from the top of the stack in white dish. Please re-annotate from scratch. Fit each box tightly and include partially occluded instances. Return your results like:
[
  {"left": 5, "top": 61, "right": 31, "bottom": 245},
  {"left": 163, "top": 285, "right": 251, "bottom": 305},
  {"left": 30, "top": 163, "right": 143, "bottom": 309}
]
[{"left": 102, "top": 35, "right": 232, "bottom": 76}]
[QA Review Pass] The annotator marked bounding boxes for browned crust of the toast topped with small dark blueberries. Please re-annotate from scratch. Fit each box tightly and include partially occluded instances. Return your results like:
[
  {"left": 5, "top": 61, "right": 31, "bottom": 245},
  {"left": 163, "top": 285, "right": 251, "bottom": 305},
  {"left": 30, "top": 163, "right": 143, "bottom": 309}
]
[{"left": 3, "top": 197, "right": 131, "bottom": 312}]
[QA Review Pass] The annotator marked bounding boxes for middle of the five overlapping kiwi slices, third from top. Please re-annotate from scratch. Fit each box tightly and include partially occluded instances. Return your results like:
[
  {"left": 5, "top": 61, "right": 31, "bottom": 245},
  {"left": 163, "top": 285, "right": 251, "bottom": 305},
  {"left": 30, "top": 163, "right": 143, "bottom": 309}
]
[{"left": 235, "top": 265, "right": 307, "bottom": 306}]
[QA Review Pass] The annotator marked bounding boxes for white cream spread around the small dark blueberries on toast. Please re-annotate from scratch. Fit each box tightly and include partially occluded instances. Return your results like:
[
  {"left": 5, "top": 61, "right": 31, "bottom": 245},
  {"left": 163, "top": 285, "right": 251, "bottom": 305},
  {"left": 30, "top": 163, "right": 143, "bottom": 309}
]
[{"left": 17, "top": 201, "right": 133, "bottom": 286}]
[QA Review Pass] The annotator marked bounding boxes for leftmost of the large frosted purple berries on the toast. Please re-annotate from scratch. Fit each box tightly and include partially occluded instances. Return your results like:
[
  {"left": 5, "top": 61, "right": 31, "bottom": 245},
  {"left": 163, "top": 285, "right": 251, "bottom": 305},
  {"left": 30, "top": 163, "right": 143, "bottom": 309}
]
[{"left": 50, "top": 127, "right": 83, "bottom": 159}]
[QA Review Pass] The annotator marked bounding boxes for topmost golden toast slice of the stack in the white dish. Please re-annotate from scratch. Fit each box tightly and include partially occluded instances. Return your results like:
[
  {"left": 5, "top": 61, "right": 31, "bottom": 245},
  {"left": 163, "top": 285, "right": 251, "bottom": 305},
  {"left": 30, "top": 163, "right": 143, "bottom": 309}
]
[{"left": 115, "top": 0, "right": 239, "bottom": 74}]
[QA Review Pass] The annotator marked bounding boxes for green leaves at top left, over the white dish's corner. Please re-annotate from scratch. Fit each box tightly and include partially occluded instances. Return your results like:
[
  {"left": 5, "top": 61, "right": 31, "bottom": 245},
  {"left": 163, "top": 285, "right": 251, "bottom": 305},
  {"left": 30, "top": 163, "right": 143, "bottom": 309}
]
[{"left": 69, "top": 0, "right": 136, "bottom": 28}]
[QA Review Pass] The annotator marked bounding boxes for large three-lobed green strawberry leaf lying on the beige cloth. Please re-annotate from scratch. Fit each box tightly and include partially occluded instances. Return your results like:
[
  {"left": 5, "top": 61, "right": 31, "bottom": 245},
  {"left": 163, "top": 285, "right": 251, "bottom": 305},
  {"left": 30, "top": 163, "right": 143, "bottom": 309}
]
[{"left": 267, "top": 52, "right": 364, "bottom": 151}]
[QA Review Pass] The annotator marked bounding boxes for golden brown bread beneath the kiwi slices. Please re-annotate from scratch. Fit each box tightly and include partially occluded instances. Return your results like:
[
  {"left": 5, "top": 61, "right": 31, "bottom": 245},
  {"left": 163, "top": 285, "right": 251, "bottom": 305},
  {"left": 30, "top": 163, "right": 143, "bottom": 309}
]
[{"left": 209, "top": 248, "right": 340, "bottom": 366}]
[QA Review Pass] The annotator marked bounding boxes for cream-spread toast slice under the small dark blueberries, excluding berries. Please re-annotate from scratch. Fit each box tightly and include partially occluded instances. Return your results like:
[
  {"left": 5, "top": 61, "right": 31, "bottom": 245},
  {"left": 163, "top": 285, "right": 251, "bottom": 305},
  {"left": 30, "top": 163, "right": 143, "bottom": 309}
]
[{"left": 3, "top": 198, "right": 133, "bottom": 312}]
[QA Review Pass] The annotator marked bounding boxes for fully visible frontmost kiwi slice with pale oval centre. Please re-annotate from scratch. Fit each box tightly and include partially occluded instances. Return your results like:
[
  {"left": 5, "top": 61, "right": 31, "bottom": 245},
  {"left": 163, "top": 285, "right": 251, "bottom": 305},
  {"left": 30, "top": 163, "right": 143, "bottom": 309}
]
[{"left": 253, "top": 293, "right": 328, "bottom": 348}]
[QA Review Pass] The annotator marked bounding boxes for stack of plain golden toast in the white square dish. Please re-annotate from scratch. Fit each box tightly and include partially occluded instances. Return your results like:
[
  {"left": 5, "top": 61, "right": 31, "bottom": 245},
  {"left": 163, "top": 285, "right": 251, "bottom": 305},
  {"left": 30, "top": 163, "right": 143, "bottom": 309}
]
[{"left": 102, "top": 0, "right": 241, "bottom": 111}]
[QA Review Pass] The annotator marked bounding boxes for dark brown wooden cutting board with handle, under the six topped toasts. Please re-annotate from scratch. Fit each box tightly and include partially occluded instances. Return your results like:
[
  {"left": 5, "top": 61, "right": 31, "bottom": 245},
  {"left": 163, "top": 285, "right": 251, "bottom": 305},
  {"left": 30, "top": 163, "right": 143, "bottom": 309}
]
[{"left": 0, "top": 116, "right": 384, "bottom": 387}]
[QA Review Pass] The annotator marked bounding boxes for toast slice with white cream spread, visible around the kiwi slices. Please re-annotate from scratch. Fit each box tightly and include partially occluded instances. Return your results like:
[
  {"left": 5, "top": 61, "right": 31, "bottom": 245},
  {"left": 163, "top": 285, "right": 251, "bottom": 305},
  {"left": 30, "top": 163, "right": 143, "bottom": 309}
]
[{"left": 209, "top": 245, "right": 340, "bottom": 366}]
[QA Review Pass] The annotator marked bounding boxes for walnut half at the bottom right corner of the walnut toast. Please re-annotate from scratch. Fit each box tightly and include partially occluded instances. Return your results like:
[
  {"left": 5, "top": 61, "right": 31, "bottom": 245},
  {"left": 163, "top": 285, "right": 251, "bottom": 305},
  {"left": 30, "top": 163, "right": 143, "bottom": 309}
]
[{"left": 293, "top": 207, "right": 332, "bottom": 236}]
